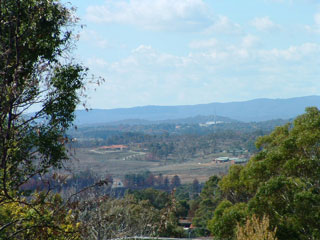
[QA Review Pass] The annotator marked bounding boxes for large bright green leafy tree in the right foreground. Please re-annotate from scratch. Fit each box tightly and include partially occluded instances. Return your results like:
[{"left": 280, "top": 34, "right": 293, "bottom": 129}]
[{"left": 210, "top": 108, "right": 320, "bottom": 239}]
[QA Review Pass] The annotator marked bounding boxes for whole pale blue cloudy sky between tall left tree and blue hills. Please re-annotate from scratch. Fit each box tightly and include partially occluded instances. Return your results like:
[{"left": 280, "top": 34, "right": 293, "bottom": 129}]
[{"left": 67, "top": 0, "right": 320, "bottom": 108}]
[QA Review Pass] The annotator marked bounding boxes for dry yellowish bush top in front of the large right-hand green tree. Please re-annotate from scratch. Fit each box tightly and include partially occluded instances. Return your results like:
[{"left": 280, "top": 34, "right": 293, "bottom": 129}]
[{"left": 237, "top": 215, "right": 277, "bottom": 240}]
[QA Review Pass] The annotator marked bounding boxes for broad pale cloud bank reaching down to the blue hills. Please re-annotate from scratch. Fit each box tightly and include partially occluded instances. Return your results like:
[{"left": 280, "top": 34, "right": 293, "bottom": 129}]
[{"left": 85, "top": 41, "right": 320, "bottom": 107}]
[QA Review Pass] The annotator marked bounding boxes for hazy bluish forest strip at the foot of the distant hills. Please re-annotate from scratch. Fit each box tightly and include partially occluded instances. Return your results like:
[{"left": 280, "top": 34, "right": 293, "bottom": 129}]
[{"left": 68, "top": 120, "right": 288, "bottom": 150}]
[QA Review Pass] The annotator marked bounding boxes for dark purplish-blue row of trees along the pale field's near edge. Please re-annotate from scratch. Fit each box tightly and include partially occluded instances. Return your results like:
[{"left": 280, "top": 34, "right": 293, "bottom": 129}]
[{"left": 20, "top": 170, "right": 202, "bottom": 201}]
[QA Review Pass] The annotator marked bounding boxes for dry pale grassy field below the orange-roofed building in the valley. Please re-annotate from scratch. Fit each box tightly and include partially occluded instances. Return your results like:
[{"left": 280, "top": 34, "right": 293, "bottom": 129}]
[{"left": 72, "top": 148, "right": 235, "bottom": 183}]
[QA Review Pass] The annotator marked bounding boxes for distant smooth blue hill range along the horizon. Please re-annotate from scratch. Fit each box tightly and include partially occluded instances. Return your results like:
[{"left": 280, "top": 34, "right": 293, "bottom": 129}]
[{"left": 76, "top": 96, "right": 320, "bottom": 125}]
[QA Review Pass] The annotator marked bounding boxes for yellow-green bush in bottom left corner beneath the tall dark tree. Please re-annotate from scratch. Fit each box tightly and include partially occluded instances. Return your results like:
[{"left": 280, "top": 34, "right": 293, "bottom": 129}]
[{"left": 0, "top": 193, "right": 81, "bottom": 240}]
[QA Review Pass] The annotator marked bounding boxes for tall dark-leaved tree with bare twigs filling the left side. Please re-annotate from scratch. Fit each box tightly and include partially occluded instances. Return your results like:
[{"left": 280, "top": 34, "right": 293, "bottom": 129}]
[{"left": 0, "top": 0, "right": 94, "bottom": 239}]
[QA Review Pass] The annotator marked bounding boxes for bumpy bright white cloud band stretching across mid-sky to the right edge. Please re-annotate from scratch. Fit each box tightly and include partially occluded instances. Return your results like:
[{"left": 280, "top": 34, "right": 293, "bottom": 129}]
[{"left": 110, "top": 42, "right": 320, "bottom": 74}]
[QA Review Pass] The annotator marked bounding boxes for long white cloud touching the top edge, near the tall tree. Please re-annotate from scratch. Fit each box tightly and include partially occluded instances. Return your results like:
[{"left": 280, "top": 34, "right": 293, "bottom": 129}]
[{"left": 86, "top": 0, "right": 211, "bottom": 30}]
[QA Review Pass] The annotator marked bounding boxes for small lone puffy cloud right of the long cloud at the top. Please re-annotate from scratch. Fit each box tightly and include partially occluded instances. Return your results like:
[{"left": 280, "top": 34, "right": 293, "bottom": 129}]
[{"left": 205, "top": 15, "right": 241, "bottom": 34}]
